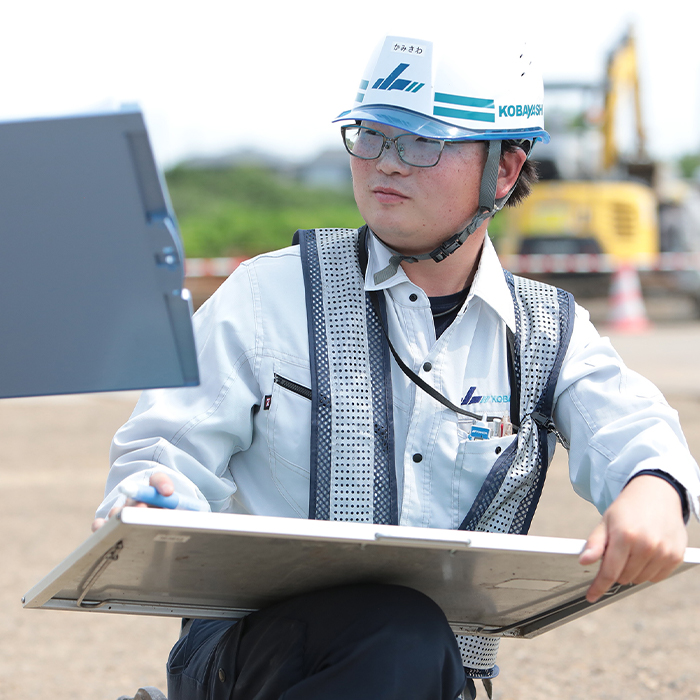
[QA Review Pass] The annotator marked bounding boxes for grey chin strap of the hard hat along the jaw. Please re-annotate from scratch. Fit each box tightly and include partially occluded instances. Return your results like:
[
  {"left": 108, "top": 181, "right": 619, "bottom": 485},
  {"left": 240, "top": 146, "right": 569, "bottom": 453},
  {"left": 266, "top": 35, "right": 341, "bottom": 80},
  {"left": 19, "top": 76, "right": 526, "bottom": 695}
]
[{"left": 374, "top": 140, "right": 515, "bottom": 284}]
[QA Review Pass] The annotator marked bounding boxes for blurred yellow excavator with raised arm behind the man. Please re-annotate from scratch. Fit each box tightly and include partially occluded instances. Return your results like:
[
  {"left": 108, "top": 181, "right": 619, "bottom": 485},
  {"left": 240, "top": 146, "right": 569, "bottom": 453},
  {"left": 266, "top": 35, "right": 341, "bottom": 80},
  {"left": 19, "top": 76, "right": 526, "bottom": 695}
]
[{"left": 501, "top": 28, "right": 660, "bottom": 262}]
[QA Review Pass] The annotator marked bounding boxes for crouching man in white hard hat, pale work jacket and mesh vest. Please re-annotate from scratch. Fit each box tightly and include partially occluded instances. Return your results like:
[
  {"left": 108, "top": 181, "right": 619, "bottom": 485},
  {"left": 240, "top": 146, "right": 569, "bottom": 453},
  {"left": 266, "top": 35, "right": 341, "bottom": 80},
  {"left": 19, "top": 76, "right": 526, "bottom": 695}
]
[{"left": 95, "top": 37, "right": 700, "bottom": 700}]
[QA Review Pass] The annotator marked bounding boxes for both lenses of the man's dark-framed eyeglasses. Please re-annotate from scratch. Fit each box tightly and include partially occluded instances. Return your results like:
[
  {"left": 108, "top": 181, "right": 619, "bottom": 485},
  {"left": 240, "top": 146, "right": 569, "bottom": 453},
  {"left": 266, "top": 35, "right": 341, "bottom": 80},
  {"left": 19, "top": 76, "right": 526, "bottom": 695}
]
[{"left": 341, "top": 126, "right": 445, "bottom": 168}]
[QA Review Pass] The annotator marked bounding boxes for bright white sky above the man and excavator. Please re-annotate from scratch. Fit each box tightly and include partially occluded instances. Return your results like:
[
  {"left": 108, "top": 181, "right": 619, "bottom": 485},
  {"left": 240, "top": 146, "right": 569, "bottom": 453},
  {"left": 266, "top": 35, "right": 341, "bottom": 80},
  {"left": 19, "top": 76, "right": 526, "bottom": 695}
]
[{"left": 0, "top": 0, "right": 700, "bottom": 167}]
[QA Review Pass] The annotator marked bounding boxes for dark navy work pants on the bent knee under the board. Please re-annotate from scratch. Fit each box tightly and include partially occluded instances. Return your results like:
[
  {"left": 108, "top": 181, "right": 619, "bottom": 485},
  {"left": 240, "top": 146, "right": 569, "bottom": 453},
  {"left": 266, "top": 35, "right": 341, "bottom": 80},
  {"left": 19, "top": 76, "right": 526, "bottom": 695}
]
[{"left": 168, "top": 584, "right": 465, "bottom": 700}]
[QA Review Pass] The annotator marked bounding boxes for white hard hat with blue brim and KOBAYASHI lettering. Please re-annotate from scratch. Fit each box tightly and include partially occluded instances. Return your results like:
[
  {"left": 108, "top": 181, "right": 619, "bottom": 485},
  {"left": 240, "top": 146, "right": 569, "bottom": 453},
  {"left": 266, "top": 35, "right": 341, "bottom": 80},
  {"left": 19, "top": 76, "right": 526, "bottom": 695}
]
[{"left": 333, "top": 32, "right": 549, "bottom": 143}]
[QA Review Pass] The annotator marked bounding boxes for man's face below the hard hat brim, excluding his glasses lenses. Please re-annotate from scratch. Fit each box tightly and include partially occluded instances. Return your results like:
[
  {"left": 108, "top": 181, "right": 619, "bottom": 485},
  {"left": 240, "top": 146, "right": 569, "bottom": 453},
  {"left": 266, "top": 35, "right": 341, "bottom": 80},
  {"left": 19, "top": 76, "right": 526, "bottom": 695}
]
[{"left": 350, "top": 122, "right": 486, "bottom": 254}]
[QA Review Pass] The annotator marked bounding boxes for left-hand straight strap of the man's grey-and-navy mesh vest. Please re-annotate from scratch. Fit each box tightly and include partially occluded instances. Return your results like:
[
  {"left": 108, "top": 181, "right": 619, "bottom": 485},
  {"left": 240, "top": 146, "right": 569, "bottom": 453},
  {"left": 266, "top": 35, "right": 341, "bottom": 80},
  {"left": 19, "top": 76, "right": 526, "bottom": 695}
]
[{"left": 300, "top": 229, "right": 398, "bottom": 525}]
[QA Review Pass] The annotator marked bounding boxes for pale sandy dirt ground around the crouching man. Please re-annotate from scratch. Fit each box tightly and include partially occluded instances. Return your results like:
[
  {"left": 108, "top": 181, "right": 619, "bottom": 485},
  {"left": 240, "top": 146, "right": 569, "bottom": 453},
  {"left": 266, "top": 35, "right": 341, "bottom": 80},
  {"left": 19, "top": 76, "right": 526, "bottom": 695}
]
[{"left": 0, "top": 314, "right": 700, "bottom": 700}]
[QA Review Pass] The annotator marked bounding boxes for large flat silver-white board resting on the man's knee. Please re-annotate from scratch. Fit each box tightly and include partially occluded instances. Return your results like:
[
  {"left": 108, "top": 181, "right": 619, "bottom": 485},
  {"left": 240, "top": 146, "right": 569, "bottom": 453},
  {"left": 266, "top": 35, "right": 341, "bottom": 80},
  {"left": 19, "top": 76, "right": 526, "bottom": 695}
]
[{"left": 22, "top": 508, "right": 700, "bottom": 638}]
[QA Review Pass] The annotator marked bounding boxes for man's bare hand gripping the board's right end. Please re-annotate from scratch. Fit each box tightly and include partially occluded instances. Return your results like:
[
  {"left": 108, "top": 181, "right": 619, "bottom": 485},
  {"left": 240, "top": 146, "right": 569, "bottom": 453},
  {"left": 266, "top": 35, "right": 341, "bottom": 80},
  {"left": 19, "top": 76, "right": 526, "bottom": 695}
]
[{"left": 579, "top": 474, "right": 688, "bottom": 603}]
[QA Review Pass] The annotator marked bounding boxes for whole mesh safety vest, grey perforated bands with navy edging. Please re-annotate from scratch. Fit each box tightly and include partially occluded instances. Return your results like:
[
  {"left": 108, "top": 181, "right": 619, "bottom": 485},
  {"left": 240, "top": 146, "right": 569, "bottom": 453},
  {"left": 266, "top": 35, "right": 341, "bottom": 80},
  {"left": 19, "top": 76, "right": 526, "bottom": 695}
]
[{"left": 299, "top": 229, "right": 573, "bottom": 678}]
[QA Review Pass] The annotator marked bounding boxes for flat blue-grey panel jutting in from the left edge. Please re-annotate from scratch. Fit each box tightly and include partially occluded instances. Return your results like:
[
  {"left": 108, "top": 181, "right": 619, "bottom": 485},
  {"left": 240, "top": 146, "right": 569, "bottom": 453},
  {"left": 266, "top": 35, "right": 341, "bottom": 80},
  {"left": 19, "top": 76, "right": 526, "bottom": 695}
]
[{"left": 0, "top": 109, "right": 199, "bottom": 398}]
